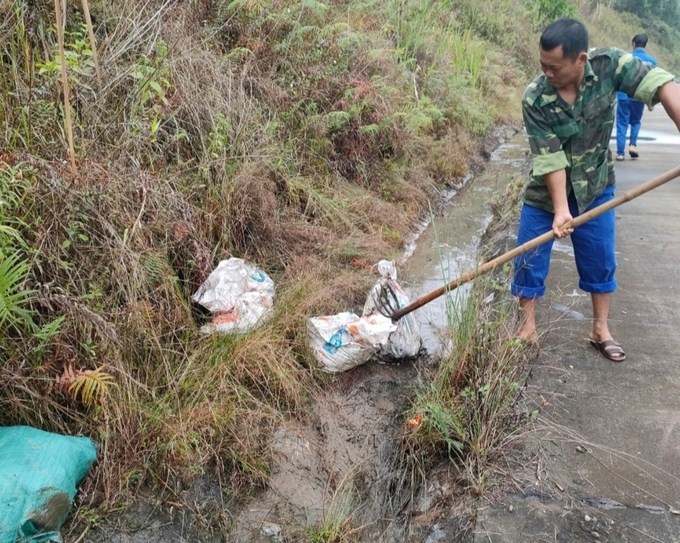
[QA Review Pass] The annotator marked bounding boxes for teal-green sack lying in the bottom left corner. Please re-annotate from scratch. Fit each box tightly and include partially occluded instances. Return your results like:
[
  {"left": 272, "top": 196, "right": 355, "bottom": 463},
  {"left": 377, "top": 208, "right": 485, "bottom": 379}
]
[{"left": 0, "top": 426, "right": 97, "bottom": 543}]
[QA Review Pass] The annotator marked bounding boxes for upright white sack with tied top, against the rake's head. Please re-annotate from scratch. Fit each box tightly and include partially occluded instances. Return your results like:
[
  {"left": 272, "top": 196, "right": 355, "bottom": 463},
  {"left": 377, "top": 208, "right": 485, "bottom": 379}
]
[{"left": 363, "top": 260, "right": 423, "bottom": 359}]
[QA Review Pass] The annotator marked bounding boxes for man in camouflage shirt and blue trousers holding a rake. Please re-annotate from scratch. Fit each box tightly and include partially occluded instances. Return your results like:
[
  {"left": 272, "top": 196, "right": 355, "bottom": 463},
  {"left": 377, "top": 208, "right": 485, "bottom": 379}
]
[{"left": 511, "top": 19, "right": 680, "bottom": 362}]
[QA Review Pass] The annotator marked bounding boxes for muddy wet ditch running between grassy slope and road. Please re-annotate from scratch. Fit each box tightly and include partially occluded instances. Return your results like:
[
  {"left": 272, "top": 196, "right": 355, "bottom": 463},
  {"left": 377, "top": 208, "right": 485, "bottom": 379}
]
[{"left": 232, "top": 134, "right": 526, "bottom": 543}]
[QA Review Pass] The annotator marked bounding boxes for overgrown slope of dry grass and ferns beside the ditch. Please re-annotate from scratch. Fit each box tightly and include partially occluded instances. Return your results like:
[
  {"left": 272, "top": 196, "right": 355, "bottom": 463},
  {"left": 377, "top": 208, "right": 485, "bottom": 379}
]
[{"left": 0, "top": 0, "right": 673, "bottom": 528}]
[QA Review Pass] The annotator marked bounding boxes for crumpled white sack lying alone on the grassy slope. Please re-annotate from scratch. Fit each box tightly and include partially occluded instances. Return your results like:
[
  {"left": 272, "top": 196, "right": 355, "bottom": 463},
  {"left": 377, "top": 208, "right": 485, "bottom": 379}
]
[{"left": 191, "top": 258, "right": 275, "bottom": 334}]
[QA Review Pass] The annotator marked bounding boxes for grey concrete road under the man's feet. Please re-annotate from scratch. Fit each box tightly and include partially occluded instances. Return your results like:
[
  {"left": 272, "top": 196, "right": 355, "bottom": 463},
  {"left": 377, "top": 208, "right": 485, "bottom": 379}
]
[{"left": 474, "top": 106, "right": 680, "bottom": 543}]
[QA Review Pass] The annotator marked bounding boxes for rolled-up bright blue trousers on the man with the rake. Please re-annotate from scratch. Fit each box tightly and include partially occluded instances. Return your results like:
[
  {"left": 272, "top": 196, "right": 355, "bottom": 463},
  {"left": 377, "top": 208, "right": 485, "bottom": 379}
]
[{"left": 510, "top": 185, "right": 616, "bottom": 298}]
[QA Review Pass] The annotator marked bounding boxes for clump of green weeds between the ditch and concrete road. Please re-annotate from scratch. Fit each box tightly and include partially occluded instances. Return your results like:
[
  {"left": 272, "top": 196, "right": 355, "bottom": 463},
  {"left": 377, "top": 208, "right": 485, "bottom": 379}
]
[{"left": 406, "top": 284, "right": 533, "bottom": 494}]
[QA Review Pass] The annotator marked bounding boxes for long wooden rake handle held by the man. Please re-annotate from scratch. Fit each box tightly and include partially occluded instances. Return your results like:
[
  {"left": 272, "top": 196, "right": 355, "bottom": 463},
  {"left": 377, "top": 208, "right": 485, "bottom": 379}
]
[{"left": 392, "top": 166, "right": 680, "bottom": 322}]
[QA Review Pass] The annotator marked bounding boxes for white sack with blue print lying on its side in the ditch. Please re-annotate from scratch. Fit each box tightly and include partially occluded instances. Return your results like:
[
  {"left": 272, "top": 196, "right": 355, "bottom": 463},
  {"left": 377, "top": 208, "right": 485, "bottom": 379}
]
[{"left": 307, "top": 311, "right": 396, "bottom": 373}]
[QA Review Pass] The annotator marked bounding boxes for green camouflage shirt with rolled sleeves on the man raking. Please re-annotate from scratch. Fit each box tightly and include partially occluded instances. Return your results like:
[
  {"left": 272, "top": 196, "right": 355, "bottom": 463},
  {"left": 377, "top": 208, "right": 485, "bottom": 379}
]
[{"left": 522, "top": 48, "right": 674, "bottom": 212}]
